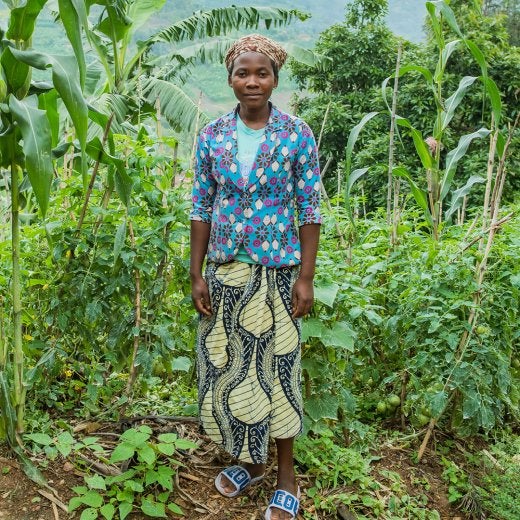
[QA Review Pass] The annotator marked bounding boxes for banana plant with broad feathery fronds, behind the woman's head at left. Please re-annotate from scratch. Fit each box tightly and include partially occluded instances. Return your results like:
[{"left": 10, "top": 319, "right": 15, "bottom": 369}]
[{"left": 71, "top": 0, "right": 319, "bottom": 132}]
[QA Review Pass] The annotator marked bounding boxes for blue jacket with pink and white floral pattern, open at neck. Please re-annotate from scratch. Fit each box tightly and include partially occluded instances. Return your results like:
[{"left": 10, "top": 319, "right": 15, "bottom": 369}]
[{"left": 190, "top": 105, "right": 321, "bottom": 267}]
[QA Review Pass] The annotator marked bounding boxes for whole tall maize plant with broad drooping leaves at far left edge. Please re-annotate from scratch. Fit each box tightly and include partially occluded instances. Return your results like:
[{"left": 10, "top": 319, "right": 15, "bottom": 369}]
[{"left": 0, "top": 0, "right": 87, "bottom": 447}]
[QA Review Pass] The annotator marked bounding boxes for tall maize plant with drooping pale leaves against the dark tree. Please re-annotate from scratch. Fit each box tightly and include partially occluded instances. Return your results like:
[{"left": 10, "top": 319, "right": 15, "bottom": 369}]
[{"left": 382, "top": 0, "right": 502, "bottom": 240}]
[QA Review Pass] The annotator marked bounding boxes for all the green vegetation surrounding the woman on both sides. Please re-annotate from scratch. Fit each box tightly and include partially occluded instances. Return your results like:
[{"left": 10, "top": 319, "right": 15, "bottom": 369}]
[{"left": 0, "top": 0, "right": 520, "bottom": 520}]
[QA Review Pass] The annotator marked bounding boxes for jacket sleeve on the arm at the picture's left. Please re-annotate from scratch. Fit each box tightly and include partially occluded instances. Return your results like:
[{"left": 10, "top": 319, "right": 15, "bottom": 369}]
[{"left": 190, "top": 130, "right": 217, "bottom": 224}]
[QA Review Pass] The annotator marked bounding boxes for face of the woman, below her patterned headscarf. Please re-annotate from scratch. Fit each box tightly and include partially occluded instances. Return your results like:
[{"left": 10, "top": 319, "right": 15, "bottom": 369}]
[{"left": 228, "top": 52, "right": 278, "bottom": 111}]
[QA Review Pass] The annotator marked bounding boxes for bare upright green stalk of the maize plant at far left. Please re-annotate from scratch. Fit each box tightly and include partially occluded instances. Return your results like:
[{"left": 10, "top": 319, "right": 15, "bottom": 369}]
[{"left": 11, "top": 132, "right": 25, "bottom": 433}]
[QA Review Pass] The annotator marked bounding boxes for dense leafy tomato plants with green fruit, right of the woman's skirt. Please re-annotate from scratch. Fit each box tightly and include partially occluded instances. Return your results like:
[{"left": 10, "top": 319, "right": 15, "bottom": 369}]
[{"left": 302, "top": 201, "right": 520, "bottom": 435}]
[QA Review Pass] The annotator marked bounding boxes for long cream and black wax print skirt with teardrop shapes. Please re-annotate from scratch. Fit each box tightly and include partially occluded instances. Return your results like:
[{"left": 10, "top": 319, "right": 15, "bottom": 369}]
[{"left": 197, "top": 261, "right": 302, "bottom": 464}]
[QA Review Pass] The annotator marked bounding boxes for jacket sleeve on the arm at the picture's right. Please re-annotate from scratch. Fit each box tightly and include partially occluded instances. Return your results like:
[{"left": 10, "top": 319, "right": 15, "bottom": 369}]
[{"left": 293, "top": 122, "right": 321, "bottom": 226}]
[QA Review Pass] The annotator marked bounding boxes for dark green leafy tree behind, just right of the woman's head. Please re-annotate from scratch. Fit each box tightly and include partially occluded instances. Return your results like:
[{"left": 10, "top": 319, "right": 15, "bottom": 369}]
[{"left": 291, "top": 0, "right": 404, "bottom": 208}]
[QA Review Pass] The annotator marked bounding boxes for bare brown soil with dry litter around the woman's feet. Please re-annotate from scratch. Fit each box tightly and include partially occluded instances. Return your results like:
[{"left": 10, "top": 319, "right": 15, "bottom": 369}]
[{"left": 0, "top": 421, "right": 465, "bottom": 520}]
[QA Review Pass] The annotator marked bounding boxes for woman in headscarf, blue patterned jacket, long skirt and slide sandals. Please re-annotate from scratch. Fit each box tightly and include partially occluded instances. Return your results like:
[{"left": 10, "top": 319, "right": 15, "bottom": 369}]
[{"left": 190, "top": 34, "right": 321, "bottom": 520}]
